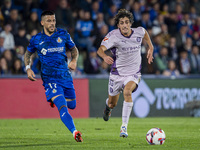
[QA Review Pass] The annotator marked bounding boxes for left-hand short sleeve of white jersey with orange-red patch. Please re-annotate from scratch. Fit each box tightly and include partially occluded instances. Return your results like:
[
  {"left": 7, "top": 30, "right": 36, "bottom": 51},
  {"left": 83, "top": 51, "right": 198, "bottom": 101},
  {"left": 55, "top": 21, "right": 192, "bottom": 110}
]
[{"left": 101, "top": 31, "right": 115, "bottom": 49}]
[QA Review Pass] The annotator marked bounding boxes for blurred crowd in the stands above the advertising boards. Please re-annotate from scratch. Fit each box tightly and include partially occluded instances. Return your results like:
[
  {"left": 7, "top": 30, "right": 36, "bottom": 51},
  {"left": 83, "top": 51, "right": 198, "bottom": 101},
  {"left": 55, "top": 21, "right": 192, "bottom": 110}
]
[{"left": 0, "top": 0, "right": 200, "bottom": 76}]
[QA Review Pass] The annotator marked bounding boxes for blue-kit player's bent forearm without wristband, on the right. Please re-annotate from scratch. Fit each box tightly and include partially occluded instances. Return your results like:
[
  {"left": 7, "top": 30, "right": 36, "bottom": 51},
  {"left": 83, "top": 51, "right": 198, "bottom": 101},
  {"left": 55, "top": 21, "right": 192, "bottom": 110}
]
[{"left": 68, "top": 47, "right": 79, "bottom": 70}]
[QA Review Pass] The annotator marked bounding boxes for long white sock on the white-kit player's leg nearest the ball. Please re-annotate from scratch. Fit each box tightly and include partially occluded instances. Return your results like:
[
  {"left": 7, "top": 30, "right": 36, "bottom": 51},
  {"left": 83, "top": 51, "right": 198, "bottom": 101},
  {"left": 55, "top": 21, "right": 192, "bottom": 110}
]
[{"left": 122, "top": 101, "right": 133, "bottom": 127}]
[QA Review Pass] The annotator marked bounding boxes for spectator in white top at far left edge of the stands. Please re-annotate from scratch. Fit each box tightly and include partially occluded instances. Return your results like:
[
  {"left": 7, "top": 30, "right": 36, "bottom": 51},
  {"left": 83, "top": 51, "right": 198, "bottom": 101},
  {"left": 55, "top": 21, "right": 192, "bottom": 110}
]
[{"left": 0, "top": 24, "right": 15, "bottom": 49}]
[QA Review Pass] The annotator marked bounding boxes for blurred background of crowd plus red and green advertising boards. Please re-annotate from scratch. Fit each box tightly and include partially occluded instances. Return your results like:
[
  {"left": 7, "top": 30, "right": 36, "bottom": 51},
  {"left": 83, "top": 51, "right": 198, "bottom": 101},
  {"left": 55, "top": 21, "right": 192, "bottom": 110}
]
[{"left": 0, "top": 0, "right": 200, "bottom": 118}]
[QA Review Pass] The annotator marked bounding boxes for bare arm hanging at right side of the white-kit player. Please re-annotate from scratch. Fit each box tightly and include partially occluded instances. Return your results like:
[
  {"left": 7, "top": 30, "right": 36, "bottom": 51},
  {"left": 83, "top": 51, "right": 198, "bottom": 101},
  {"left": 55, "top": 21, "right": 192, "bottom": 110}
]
[{"left": 144, "top": 30, "right": 153, "bottom": 64}]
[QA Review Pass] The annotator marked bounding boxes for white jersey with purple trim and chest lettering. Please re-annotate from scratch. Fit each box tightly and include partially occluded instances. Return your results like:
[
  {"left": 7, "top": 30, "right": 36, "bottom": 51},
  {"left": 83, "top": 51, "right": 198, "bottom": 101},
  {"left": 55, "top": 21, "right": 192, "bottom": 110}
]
[{"left": 101, "top": 27, "right": 145, "bottom": 76}]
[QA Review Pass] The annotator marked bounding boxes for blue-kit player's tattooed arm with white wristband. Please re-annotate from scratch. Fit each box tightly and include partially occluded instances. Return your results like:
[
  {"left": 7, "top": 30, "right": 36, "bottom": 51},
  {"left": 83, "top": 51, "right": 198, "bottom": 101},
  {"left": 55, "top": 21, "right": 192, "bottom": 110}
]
[{"left": 24, "top": 50, "right": 36, "bottom": 81}]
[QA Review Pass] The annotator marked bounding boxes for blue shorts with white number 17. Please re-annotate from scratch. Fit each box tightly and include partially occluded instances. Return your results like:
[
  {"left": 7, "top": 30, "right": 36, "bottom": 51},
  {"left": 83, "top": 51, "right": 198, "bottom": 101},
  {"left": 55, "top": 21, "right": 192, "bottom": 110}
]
[{"left": 44, "top": 83, "right": 76, "bottom": 102}]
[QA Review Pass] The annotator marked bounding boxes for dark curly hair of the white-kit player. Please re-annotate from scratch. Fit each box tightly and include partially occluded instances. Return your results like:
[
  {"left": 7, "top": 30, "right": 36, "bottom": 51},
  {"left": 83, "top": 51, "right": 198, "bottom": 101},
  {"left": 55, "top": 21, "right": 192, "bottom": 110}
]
[{"left": 114, "top": 9, "right": 134, "bottom": 25}]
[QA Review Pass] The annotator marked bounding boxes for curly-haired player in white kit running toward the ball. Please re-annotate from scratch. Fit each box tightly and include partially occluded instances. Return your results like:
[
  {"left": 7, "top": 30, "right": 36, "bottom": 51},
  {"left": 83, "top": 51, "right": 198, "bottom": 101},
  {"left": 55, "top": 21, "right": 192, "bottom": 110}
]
[{"left": 97, "top": 9, "right": 153, "bottom": 138}]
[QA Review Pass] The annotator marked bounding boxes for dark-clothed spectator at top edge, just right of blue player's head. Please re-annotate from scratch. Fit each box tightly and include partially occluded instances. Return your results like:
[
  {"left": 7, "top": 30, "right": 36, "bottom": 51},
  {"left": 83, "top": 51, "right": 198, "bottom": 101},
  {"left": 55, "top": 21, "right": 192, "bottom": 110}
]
[{"left": 55, "top": 0, "right": 75, "bottom": 34}]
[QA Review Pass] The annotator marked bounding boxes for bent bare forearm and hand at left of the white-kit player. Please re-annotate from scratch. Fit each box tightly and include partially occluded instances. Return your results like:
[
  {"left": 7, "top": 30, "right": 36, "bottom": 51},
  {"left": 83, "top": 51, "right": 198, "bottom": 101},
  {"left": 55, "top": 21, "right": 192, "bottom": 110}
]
[{"left": 97, "top": 45, "right": 114, "bottom": 65}]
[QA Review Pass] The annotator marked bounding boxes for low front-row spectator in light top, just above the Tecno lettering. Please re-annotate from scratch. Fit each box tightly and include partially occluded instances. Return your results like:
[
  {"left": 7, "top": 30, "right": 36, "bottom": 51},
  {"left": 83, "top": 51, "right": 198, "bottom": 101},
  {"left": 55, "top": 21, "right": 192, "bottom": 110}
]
[{"left": 163, "top": 60, "right": 180, "bottom": 77}]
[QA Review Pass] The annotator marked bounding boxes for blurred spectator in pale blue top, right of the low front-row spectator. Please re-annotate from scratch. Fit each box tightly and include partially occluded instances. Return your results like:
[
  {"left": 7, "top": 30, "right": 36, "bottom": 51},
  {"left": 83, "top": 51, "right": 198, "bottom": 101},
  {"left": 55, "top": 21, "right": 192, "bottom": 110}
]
[{"left": 179, "top": 50, "right": 191, "bottom": 75}]
